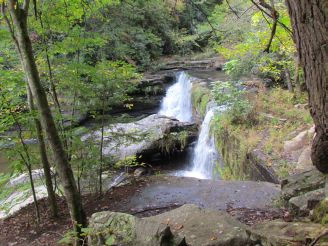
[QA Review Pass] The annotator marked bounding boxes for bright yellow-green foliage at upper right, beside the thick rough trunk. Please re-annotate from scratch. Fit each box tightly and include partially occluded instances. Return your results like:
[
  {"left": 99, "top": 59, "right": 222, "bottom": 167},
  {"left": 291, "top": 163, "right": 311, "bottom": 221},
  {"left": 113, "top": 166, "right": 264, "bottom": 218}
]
[{"left": 211, "top": 0, "right": 295, "bottom": 82}]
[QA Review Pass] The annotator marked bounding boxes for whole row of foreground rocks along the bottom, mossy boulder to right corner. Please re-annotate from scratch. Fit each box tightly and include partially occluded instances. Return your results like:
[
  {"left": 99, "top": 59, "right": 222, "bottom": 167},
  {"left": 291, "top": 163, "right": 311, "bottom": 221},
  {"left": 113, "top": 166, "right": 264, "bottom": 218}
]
[{"left": 89, "top": 204, "right": 327, "bottom": 246}]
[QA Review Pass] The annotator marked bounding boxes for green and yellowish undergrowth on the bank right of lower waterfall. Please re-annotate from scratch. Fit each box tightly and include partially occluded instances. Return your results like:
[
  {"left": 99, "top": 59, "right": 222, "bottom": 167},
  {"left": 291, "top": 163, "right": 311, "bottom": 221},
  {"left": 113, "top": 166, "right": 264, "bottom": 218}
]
[{"left": 212, "top": 82, "right": 313, "bottom": 179}]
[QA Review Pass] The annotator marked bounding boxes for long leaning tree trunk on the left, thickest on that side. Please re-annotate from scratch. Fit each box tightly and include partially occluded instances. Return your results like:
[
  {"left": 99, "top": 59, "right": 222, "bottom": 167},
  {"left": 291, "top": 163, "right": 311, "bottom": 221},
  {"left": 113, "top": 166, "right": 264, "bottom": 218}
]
[{"left": 8, "top": 0, "right": 86, "bottom": 238}]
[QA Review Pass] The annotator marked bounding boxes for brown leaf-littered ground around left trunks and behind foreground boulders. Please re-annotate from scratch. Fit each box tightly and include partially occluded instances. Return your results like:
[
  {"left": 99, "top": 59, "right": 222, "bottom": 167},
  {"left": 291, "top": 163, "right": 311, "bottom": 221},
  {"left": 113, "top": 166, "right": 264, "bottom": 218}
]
[{"left": 0, "top": 178, "right": 285, "bottom": 246}]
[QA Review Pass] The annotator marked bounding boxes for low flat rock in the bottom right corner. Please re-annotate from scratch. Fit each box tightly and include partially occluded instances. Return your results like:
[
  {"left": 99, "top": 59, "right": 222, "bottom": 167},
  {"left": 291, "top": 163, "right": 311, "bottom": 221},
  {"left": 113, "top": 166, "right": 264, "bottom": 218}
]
[{"left": 252, "top": 220, "right": 328, "bottom": 246}]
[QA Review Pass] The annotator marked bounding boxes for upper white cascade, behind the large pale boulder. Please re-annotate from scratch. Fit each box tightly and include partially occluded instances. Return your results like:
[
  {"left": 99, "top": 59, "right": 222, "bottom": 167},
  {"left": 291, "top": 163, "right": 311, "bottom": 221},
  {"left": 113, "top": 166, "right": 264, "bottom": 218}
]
[{"left": 159, "top": 72, "right": 192, "bottom": 122}]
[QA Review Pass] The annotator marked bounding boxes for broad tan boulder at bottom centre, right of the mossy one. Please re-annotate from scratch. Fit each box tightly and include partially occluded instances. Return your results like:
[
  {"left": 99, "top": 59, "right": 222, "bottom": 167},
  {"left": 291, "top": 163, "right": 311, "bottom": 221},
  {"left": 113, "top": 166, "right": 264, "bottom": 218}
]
[{"left": 145, "top": 204, "right": 253, "bottom": 246}]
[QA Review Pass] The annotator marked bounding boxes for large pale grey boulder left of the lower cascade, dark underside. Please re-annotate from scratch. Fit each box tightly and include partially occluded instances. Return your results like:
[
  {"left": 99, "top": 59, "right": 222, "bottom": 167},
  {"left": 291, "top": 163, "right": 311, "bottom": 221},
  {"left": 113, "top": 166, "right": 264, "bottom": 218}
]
[{"left": 82, "top": 114, "right": 197, "bottom": 160}]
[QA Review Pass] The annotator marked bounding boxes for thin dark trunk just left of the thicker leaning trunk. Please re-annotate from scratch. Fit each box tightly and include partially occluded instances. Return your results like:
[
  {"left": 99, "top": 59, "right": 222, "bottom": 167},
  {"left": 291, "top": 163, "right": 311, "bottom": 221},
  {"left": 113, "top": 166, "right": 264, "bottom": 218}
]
[{"left": 27, "top": 86, "right": 58, "bottom": 217}]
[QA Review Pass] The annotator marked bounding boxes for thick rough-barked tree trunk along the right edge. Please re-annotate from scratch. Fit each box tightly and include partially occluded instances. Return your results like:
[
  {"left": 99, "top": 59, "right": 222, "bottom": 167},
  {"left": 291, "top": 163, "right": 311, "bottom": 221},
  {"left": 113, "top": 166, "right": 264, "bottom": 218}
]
[{"left": 286, "top": 0, "right": 328, "bottom": 173}]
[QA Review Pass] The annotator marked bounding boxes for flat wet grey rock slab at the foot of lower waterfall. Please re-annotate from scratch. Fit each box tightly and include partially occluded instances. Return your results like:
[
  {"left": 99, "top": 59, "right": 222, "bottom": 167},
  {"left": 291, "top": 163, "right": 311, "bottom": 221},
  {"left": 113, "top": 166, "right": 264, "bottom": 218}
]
[{"left": 127, "top": 176, "right": 280, "bottom": 211}]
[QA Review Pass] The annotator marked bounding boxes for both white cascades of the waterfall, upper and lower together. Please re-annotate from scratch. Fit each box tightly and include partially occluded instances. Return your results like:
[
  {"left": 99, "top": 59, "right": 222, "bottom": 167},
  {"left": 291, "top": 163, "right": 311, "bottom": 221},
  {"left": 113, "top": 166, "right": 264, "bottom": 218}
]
[{"left": 159, "top": 72, "right": 220, "bottom": 179}]
